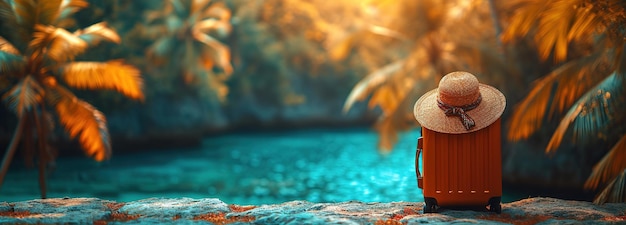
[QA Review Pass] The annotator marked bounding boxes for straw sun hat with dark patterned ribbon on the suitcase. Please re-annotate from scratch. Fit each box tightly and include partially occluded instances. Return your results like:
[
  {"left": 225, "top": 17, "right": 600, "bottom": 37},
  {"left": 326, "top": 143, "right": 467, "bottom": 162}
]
[{"left": 413, "top": 71, "right": 506, "bottom": 134}]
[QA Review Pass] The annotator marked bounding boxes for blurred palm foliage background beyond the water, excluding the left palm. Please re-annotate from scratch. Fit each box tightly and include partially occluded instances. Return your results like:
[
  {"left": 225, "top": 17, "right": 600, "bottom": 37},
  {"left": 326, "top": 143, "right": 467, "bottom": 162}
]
[{"left": 0, "top": 0, "right": 626, "bottom": 203}]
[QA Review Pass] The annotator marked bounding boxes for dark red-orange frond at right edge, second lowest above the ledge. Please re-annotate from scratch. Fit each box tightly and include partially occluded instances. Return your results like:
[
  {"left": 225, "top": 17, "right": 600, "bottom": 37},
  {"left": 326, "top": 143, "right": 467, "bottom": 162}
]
[{"left": 585, "top": 135, "right": 626, "bottom": 189}]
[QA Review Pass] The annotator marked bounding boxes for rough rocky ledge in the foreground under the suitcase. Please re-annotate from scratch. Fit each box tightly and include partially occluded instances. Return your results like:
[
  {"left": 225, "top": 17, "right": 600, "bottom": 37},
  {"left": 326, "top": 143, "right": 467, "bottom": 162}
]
[{"left": 0, "top": 198, "right": 626, "bottom": 224}]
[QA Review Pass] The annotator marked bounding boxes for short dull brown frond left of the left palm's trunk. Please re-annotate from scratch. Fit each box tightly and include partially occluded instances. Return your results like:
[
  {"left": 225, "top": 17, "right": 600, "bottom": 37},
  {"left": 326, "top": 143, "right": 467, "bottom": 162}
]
[{"left": 2, "top": 76, "right": 44, "bottom": 117}]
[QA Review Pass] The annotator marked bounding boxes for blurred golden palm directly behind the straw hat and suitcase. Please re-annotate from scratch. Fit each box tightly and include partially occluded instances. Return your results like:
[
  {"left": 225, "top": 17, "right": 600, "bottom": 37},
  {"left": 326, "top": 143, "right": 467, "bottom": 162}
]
[{"left": 340, "top": 0, "right": 518, "bottom": 152}]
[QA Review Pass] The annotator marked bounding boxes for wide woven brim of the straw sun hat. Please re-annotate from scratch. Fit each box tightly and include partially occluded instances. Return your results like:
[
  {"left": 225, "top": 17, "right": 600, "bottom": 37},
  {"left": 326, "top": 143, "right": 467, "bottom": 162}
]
[{"left": 413, "top": 84, "right": 506, "bottom": 134}]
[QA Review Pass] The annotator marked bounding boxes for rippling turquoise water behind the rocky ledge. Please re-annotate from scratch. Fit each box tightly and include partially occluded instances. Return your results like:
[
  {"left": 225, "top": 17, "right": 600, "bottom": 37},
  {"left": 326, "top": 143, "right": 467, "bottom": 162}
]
[{"left": 0, "top": 128, "right": 507, "bottom": 205}]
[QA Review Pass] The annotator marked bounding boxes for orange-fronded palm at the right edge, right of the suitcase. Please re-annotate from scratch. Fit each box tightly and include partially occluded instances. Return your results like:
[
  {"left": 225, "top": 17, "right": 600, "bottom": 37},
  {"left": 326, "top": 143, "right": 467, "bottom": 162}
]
[{"left": 502, "top": 0, "right": 626, "bottom": 204}]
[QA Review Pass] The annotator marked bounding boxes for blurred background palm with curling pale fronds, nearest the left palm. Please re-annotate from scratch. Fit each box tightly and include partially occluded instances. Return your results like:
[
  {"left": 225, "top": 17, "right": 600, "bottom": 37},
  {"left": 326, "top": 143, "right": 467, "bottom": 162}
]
[{"left": 145, "top": 0, "right": 233, "bottom": 101}]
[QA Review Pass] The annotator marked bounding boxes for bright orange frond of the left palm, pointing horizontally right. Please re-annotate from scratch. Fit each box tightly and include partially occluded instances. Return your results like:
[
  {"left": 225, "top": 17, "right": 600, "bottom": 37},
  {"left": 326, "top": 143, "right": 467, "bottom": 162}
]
[{"left": 63, "top": 60, "right": 144, "bottom": 100}]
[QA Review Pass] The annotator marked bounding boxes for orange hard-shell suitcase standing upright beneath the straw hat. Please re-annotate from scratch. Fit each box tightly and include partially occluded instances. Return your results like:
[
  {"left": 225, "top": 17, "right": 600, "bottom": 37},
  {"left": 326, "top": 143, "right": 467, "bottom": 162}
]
[{"left": 415, "top": 119, "right": 502, "bottom": 213}]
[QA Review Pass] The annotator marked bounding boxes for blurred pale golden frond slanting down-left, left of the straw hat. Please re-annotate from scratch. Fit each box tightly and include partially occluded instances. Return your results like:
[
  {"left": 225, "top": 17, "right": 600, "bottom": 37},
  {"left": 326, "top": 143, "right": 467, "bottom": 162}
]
[{"left": 343, "top": 60, "right": 405, "bottom": 113}]
